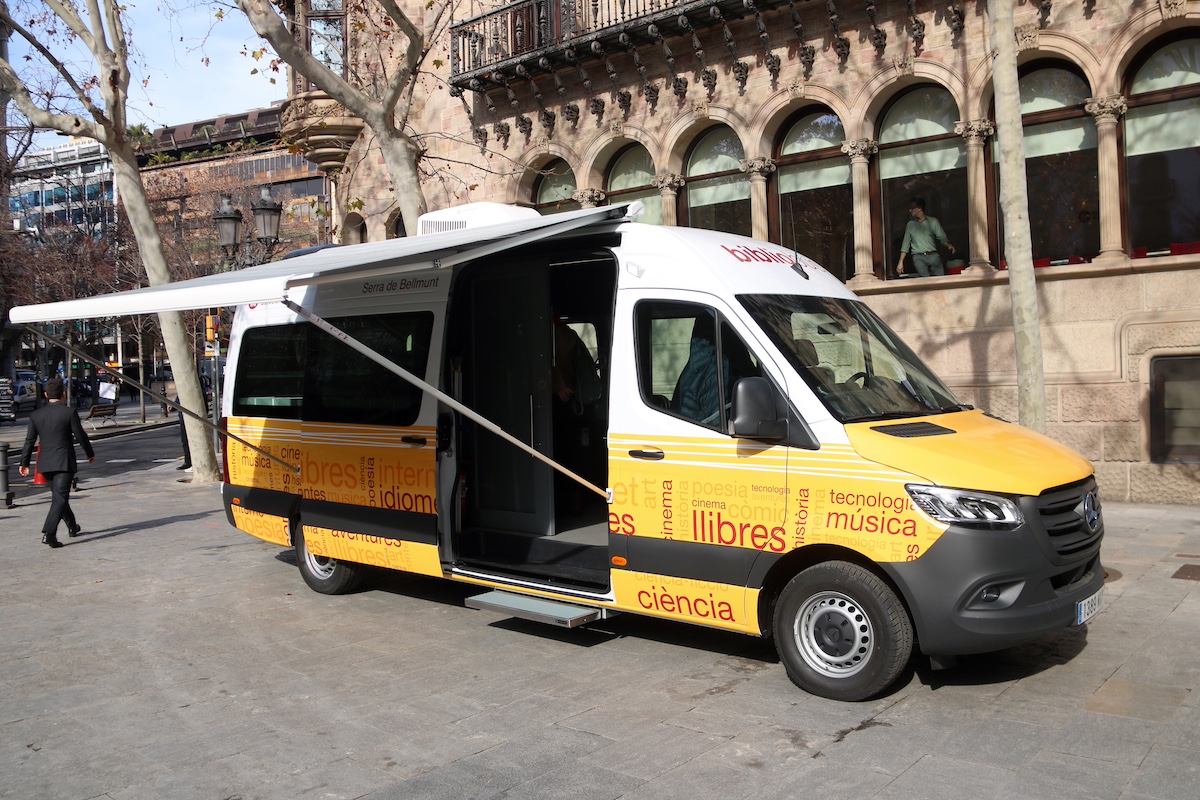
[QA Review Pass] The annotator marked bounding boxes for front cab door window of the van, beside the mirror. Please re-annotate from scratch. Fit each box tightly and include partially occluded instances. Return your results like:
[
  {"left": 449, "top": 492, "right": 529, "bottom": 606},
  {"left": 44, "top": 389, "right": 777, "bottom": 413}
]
[{"left": 637, "top": 302, "right": 762, "bottom": 431}]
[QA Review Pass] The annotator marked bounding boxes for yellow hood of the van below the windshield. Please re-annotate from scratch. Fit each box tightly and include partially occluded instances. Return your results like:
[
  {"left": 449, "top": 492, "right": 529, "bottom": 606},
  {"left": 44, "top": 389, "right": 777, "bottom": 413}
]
[{"left": 846, "top": 410, "right": 1092, "bottom": 495}]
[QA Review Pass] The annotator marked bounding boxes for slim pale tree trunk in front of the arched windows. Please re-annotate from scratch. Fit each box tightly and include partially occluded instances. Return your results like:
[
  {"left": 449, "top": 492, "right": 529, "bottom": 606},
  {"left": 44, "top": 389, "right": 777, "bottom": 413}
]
[{"left": 988, "top": 0, "right": 1046, "bottom": 433}]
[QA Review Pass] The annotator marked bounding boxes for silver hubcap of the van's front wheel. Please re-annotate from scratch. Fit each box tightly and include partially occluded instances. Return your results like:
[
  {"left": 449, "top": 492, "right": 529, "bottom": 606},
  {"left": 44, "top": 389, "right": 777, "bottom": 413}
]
[{"left": 794, "top": 591, "right": 875, "bottom": 678}]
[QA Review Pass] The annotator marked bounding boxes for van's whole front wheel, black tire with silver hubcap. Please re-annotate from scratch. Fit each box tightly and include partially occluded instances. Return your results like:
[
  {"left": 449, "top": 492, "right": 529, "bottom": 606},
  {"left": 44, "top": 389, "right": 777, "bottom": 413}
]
[{"left": 773, "top": 561, "right": 913, "bottom": 700}]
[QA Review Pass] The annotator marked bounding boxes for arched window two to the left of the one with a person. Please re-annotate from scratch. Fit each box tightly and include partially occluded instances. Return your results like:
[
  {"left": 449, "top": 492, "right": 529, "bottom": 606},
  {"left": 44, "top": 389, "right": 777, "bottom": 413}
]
[{"left": 682, "top": 125, "right": 751, "bottom": 236}]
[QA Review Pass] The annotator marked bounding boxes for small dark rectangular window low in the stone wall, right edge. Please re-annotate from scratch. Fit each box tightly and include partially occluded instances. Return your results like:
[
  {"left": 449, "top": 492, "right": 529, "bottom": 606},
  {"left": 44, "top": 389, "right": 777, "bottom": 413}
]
[{"left": 1150, "top": 356, "right": 1200, "bottom": 464}]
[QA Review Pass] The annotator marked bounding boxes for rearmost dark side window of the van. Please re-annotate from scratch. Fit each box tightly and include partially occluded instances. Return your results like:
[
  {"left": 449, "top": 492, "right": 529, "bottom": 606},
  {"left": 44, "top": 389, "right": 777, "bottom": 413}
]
[{"left": 233, "top": 323, "right": 304, "bottom": 420}]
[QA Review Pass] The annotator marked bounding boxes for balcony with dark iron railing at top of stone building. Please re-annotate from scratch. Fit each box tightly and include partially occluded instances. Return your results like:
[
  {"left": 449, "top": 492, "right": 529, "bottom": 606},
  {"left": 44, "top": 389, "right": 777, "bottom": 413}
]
[{"left": 450, "top": 0, "right": 799, "bottom": 91}]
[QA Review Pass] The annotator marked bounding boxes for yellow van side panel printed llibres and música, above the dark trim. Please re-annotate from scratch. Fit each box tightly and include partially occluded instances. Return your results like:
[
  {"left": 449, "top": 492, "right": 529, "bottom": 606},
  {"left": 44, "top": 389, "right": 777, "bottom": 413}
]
[{"left": 608, "top": 434, "right": 947, "bottom": 567}]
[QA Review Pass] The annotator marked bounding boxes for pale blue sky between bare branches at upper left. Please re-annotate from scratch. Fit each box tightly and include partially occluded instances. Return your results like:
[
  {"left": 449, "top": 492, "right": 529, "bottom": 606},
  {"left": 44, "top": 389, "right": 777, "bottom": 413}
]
[{"left": 12, "top": 0, "right": 287, "bottom": 146}]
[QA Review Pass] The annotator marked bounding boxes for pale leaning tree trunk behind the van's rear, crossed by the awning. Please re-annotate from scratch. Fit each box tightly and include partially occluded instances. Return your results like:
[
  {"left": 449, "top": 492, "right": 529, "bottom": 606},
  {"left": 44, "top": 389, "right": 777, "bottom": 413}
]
[{"left": 108, "top": 142, "right": 221, "bottom": 483}]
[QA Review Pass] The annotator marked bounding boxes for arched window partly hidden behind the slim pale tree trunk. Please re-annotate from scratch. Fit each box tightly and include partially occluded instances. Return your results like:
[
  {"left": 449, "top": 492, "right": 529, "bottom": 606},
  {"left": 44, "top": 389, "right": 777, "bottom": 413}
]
[{"left": 990, "top": 62, "right": 1100, "bottom": 266}]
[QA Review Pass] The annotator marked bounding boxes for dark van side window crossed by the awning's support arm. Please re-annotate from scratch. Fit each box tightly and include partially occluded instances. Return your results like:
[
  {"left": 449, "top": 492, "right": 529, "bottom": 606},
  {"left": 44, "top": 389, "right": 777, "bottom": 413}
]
[{"left": 304, "top": 311, "right": 433, "bottom": 426}]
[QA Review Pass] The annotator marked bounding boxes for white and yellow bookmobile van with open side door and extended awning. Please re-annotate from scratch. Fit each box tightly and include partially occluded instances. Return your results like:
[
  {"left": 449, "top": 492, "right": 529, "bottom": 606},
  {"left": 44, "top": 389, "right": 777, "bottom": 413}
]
[{"left": 14, "top": 204, "right": 1104, "bottom": 699}]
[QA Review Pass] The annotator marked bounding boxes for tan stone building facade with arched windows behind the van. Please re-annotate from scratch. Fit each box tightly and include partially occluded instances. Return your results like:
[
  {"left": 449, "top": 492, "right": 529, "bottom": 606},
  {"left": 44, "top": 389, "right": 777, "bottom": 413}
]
[{"left": 284, "top": 0, "right": 1200, "bottom": 503}]
